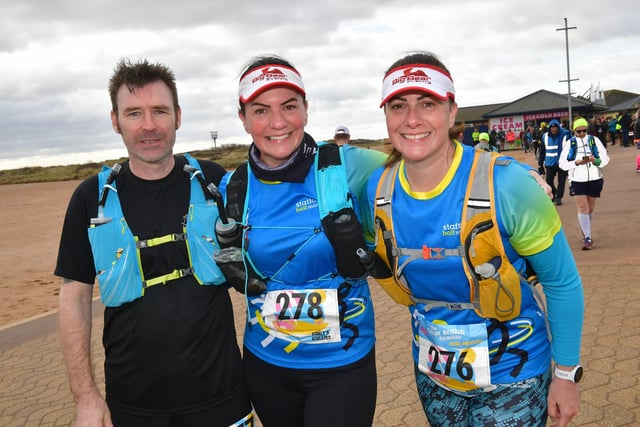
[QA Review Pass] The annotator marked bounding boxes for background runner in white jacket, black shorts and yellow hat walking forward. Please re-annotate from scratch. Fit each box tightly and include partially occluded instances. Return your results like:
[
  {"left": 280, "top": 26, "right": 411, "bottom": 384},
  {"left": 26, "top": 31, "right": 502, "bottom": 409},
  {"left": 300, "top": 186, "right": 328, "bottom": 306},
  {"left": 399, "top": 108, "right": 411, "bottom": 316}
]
[{"left": 559, "top": 118, "right": 609, "bottom": 250}]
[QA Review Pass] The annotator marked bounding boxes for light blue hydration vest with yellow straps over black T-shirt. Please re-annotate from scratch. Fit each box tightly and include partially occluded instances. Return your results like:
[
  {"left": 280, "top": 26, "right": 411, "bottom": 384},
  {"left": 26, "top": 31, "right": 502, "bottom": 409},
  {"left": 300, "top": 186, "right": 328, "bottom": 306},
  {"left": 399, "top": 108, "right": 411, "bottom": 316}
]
[{"left": 88, "top": 154, "right": 225, "bottom": 307}]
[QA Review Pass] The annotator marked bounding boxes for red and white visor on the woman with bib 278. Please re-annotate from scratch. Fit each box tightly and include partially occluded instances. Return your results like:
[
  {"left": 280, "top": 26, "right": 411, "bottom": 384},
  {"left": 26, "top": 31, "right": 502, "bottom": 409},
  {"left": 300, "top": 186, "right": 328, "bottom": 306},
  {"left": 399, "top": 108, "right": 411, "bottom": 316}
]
[{"left": 238, "top": 64, "right": 305, "bottom": 104}]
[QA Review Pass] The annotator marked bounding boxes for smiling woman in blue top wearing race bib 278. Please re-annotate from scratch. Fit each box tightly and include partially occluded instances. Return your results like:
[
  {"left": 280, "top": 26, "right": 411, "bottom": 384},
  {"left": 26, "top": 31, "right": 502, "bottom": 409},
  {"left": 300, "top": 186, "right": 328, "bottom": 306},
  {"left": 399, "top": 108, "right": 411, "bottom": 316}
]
[{"left": 220, "top": 56, "right": 386, "bottom": 427}]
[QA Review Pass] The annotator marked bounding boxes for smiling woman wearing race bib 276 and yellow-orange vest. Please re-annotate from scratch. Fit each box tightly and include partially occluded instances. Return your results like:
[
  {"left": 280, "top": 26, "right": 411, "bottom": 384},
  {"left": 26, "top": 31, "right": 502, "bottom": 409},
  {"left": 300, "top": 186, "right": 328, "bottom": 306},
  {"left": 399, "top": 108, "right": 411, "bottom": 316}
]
[{"left": 368, "top": 52, "right": 583, "bottom": 426}]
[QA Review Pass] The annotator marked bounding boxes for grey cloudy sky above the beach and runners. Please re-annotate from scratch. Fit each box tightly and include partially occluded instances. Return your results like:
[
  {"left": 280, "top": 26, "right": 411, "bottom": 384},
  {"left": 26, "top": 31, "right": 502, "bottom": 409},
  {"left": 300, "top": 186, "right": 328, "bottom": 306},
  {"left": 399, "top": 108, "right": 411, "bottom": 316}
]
[{"left": 0, "top": 0, "right": 640, "bottom": 169}]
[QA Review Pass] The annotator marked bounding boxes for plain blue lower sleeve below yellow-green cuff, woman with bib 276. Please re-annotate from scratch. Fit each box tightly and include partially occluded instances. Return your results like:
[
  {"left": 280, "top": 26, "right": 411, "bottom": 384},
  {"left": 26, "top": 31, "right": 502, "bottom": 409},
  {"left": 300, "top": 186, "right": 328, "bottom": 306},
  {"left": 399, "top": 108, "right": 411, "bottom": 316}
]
[{"left": 527, "top": 230, "right": 584, "bottom": 366}]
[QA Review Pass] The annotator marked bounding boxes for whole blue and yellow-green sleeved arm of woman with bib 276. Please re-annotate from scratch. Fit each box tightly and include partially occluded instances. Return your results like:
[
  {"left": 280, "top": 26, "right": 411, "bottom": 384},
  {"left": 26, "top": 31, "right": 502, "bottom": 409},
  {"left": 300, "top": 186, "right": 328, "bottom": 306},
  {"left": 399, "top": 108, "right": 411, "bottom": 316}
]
[{"left": 494, "top": 164, "right": 584, "bottom": 366}]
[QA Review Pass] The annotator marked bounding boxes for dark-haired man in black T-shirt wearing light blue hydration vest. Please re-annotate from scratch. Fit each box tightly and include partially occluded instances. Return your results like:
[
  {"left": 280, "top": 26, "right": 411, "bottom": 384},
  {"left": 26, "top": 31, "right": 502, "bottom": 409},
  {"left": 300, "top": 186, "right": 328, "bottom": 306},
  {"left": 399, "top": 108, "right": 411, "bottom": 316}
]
[{"left": 55, "top": 60, "right": 252, "bottom": 427}]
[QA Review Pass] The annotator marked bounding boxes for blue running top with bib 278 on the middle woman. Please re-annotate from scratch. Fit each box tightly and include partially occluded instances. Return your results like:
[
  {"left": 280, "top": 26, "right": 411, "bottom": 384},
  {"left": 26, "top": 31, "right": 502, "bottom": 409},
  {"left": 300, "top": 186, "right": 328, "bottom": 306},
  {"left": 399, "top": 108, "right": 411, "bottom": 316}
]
[{"left": 220, "top": 143, "right": 383, "bottom": 369}]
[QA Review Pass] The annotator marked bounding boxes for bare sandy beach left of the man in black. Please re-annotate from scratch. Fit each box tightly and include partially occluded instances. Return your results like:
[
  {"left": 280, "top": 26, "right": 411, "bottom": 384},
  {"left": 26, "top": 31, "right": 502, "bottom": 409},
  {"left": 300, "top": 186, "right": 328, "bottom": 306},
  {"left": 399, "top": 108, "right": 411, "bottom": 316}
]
[{"left": 0, "top": 181, "right": 84, "bottom": 327}]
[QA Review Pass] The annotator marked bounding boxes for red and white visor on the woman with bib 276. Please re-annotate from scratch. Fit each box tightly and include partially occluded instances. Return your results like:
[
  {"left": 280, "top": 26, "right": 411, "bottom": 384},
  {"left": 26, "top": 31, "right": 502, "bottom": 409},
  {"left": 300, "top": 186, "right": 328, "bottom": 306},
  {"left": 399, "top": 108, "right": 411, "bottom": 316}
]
[{"left": 380, "top": 64, "right": 456, "bottom": 108}]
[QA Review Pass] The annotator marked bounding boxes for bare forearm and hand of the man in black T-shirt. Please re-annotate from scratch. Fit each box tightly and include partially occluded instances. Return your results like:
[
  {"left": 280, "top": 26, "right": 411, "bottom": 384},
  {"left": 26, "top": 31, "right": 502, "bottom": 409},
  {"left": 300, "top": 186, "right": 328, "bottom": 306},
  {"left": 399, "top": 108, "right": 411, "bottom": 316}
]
[{"left": 58, "top": 281, "right": 113, "bottom": 426}]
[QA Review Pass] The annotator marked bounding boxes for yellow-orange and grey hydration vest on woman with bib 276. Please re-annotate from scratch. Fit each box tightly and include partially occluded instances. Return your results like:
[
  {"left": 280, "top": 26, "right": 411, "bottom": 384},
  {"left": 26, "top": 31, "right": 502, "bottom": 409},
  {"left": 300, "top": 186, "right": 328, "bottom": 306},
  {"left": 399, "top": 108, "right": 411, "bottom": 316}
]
[{"left": 374, "top": 151, "right": 524, "bottom": 321}]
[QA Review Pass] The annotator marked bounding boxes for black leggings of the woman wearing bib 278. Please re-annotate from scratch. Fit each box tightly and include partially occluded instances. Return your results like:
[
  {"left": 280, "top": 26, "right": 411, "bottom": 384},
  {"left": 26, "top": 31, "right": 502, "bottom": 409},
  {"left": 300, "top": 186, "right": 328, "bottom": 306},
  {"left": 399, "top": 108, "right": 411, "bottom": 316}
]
[{"left": 243, "top": 348, "right": 377, "bottom": 427}]
